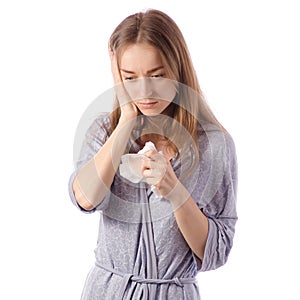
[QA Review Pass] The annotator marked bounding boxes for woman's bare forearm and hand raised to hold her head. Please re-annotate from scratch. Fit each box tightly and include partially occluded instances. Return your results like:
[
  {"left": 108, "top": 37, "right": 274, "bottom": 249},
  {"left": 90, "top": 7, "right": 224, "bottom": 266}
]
[{"left": 73, "top": 51, "right": 138, "bottom": 210}]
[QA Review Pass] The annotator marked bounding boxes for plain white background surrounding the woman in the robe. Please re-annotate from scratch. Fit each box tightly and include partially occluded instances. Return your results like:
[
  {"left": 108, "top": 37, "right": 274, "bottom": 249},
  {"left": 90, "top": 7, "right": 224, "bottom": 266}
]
[{"left": 0, "top": 0, "right": 300, "bottom": 300}]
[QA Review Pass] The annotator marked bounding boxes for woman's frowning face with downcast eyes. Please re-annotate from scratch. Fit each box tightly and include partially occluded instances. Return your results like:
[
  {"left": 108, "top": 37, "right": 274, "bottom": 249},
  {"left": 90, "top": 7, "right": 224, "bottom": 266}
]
[{"left": 120, "top": 43, "right": 176, "bottom": 116}]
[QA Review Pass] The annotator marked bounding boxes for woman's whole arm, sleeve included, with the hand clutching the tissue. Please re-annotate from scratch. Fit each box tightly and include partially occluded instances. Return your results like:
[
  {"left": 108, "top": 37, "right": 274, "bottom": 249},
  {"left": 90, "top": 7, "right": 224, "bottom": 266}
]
[{"left": 143, "top": 133, "right": 237, "bottom": 271}]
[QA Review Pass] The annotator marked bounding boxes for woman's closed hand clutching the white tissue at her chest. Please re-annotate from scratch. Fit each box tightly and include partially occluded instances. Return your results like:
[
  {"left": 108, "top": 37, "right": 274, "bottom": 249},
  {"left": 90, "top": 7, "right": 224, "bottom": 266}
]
[{"left": 142, "top": 150, "right": 183, "bottom": 201}]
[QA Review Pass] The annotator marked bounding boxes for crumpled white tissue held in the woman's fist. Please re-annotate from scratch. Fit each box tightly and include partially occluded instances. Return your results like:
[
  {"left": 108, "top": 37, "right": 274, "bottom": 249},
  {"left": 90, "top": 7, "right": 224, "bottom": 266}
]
[{"left": 119, "top": 142, "right": 162, "bottom": 198}]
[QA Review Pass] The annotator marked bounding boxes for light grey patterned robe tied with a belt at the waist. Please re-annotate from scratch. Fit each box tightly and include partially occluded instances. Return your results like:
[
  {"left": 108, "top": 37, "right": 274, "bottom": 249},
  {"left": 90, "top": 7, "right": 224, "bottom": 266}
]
[{"left": 69, "top": 114, "right": 237, "bottom": 300}]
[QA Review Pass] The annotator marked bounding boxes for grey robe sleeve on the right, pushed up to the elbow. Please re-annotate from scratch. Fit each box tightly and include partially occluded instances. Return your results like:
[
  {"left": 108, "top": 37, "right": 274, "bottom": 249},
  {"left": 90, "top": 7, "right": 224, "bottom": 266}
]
[{"left": 196, "top": 132, "right": 237, "bottom": 271}]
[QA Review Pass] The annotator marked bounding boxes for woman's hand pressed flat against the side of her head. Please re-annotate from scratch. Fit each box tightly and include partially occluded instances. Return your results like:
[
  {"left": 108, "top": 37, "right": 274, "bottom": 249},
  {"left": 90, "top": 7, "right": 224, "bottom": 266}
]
[{"left": 109, "top": 50, "right": 138, "bottom": 120}]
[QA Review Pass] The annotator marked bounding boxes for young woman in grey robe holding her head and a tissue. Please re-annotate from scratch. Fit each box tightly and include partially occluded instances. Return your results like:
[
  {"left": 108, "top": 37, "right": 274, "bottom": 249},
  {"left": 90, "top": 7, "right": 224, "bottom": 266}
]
[{"left": 69, "top": 10, "right": 237, "bottom": 300}]
